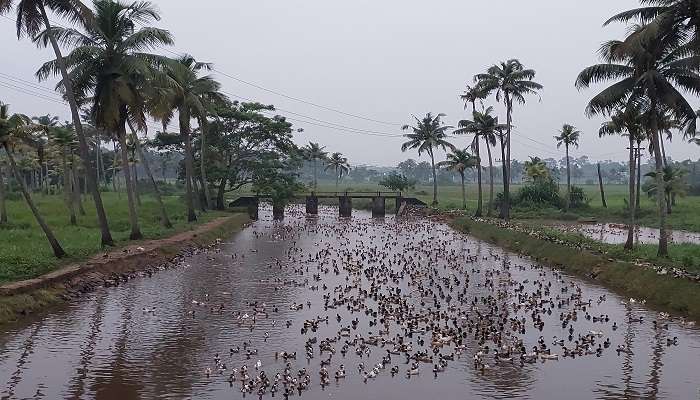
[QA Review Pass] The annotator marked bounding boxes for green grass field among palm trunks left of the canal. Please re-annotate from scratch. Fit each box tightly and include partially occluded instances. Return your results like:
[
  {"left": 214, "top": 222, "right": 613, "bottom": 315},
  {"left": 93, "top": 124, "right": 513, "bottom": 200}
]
[{"left": 0, "top": 192, "right": 228, "bottom": 283}]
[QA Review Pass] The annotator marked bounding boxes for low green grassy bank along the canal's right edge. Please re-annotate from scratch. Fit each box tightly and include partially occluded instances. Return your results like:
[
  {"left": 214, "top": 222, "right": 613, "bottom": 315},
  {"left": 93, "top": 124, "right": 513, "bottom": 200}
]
[{"left": 450, "top": 217, "right": 700, "bottom": 321}]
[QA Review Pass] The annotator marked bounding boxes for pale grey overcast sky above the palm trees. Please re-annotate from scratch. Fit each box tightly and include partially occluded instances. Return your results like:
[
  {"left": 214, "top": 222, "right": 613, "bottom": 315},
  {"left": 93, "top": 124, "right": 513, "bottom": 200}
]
[{"left": 0, "top": 0, "right": 700, "bottom": 166}]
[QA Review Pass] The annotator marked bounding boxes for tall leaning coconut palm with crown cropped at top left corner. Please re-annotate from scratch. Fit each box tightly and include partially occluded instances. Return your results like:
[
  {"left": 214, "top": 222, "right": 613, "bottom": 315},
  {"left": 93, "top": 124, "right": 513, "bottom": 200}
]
[{"left": 0, "top": 0, "right": 114, "bottom": 246}]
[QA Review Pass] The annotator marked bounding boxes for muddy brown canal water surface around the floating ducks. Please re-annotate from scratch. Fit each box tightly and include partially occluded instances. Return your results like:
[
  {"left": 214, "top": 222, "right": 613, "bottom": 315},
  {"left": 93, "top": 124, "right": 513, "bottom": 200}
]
[{"left": 0, "top": 208, "right": 700, "bottom": 400}]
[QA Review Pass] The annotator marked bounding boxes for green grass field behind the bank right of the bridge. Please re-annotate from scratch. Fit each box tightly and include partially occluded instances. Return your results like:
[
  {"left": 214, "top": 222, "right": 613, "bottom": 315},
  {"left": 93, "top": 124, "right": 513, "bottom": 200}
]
[{"left": 308, "top": 181, "right": 700, "bottom": 232}]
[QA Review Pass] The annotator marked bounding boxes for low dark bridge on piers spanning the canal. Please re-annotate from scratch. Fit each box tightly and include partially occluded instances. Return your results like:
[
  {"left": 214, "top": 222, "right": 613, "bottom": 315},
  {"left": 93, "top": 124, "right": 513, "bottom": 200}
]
[{"left": 229, "top": 191, "right": 427, "bottom": 220}]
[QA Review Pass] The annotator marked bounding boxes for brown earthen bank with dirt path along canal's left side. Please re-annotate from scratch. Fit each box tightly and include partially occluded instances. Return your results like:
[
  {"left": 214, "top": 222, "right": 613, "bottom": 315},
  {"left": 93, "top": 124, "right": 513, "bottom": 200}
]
[{"left": 0, "top": 214, "right": 249, "bottom": 324}]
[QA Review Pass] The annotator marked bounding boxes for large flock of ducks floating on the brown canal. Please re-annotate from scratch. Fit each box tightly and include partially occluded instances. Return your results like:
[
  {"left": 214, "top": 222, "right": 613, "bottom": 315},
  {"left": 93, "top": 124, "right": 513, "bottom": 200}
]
[{"left": 176, "top": 205, "right": 693, "bottom": 398}]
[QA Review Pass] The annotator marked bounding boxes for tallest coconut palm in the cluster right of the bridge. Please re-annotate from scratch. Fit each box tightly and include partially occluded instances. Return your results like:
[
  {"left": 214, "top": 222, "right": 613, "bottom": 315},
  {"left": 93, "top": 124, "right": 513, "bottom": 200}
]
[{"left": 474, "top": 59, "right": 542, "bottom": 220}]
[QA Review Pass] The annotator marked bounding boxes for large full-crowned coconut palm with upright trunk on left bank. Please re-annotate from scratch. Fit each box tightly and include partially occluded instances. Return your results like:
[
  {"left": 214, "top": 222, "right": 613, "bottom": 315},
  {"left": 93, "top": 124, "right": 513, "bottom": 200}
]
[{"left": 37, "top": 0, "right": 173, "bottom": 240}]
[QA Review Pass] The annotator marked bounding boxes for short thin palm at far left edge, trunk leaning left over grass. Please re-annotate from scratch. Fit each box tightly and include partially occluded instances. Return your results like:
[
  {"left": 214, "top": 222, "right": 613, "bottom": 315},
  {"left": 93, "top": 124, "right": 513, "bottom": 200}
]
[{"left": 0, "top": 103, "right": 66, "bottom": 258}]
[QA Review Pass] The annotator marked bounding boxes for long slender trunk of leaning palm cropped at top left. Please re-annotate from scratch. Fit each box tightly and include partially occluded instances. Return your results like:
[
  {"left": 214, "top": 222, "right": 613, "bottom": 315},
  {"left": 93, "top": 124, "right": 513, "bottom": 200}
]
[{"left": 38, "top": 3, "right": 114, "bottom": 246}]
